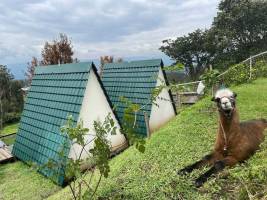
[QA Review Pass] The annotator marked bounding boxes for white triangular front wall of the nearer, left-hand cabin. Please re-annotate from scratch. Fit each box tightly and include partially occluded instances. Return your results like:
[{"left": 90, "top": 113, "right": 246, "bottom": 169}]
[{"left": 69, "top": 70, "right": 126, "bottom": 159}]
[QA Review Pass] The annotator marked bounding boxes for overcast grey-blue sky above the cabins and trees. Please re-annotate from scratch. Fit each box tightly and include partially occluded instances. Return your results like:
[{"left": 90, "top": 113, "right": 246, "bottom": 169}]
[{"left": 0, "top": 0, "right": 219, "bottom": 64}]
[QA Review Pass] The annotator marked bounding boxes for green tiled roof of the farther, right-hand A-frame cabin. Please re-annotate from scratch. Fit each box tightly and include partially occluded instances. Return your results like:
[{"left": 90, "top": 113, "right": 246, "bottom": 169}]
[{"left": 101, "top": 59, "right": 163, "bottom": 136}]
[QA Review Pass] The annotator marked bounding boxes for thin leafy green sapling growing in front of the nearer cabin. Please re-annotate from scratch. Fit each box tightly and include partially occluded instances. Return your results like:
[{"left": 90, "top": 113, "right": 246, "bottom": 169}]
[{"left": 41, "top": 102, "right": 145, "bottom": 200}]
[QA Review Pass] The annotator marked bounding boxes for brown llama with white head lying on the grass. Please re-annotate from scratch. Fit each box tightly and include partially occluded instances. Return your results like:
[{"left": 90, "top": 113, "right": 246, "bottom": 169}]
[{"left": 178, "top": 89, "right": 267, "bottom": 187}]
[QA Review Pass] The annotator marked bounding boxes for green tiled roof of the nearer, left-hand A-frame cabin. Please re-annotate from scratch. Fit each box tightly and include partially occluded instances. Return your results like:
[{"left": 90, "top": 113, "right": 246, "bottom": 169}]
[{"left": 12, "top": 62, "right": 94, "bottom": 184}]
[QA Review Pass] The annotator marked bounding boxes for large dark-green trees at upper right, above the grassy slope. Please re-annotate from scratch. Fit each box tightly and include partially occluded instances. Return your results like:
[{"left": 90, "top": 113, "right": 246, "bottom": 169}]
[{"left": 160, "top": 0, "right": 267, "bottom": 79}]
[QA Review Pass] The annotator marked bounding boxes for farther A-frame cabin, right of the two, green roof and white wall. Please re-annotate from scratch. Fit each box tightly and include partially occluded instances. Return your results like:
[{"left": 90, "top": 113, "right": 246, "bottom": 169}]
[{"left": 101, "top": 59, "right": 176, "bottom": 136}]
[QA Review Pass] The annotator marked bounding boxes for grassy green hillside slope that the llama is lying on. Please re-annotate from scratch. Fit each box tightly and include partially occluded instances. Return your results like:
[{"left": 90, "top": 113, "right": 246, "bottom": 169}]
[{"left": 50, "top": 79, "right": 267, "bottom": 199}]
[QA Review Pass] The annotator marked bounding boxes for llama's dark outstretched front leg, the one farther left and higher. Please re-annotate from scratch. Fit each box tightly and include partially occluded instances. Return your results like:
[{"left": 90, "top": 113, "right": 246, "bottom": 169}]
[{"left": 178, "top": 153, "right": 218, "bottom": 175}]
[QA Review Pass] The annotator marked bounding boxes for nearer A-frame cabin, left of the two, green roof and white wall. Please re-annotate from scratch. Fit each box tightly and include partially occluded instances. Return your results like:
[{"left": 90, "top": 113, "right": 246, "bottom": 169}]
[{"left": 12, "top": 62, "right": 126, "bottom": 184}]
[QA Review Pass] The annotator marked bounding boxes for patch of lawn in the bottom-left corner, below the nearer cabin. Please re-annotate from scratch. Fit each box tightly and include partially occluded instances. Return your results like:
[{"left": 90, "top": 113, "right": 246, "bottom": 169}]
[{"left": 0, "top": 162, "right": 60, "bottom": 200}]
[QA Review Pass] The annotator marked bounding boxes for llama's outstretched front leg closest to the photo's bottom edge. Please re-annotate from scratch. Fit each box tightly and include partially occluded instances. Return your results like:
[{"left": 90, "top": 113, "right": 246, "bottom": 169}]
[{"left": 195, "top": 156, "right": 238, "bottom": 187}]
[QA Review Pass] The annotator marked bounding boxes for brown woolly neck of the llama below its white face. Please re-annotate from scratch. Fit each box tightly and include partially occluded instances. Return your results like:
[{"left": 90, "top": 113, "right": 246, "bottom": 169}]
[{"left": 219, "top": 108, "right": 239, "bottom": 135}]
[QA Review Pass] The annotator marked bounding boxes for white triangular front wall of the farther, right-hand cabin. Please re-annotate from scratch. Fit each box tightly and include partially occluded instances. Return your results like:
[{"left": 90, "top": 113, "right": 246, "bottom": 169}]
[{"left": 149, "top": 69, "right": 175, "bottom": 133}]
